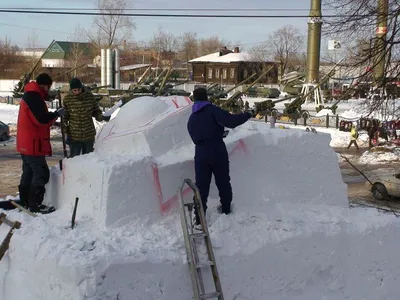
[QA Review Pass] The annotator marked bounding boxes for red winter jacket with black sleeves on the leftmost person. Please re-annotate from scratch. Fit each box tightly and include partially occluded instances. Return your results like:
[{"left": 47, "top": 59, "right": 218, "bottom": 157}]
[{"left": 17, "top": 82, "right": 58, "bottom": 156}]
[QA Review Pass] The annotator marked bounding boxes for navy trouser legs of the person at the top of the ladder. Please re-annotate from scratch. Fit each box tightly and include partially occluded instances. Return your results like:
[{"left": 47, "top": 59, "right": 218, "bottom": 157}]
[{"left": 194, "top": 141, "right": 232, "bottom": 215}]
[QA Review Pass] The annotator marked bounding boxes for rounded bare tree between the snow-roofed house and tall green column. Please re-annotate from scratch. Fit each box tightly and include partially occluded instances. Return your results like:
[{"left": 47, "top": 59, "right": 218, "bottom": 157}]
[{"left": 266, "top": 25, "right": 305, "bottom": 75}]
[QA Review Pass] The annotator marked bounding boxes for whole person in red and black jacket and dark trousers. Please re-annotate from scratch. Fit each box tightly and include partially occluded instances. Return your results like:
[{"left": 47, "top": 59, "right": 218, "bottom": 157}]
[{"left": 17, "top": 73, "right": 64, "bottom": 213}]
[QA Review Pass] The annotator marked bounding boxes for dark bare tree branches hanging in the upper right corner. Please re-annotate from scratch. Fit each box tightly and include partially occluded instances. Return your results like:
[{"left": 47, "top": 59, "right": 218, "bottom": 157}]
[{"left": 323, "top": 0, "right": 400, "bottom": 82}]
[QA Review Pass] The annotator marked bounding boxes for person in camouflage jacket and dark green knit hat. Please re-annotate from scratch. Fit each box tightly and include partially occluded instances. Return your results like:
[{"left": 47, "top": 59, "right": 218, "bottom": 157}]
[{"left": 63, "top": 78, "right": 110, "bottom": 157}]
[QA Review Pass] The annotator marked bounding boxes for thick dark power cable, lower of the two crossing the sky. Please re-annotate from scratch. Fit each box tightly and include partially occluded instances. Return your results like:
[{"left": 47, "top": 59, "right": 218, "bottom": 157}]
[{"left": 0, "top": 9, "right": 354, "bottom": 19}]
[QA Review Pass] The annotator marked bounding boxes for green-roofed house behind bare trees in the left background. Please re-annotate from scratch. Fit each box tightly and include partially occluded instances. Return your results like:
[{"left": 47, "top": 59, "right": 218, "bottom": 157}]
[{"left": 42, "top": 41, "right": 94, "bottom": 68}]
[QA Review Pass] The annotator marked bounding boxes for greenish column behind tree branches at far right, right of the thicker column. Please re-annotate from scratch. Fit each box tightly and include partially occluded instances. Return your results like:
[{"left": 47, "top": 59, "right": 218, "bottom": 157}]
[{"left": 373, "top": 0, "right": 389, "bottom": 87}]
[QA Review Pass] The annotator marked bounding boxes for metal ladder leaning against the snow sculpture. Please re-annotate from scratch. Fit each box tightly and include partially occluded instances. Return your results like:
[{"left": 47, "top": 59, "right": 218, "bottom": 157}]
[{"left": 178, "top": 179, "right": 224, "bottom": 300}]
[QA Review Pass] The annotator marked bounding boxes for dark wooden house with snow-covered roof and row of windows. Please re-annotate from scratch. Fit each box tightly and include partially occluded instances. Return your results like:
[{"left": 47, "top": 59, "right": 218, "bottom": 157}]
[{"left": 189, "top": 47, "right": 278, "bottom": 85}]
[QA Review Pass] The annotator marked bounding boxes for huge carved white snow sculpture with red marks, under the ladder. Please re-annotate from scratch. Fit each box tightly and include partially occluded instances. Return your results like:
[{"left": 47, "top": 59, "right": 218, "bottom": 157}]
[{"left": 0, "top": 97, "right": 400, "bottom": 300}]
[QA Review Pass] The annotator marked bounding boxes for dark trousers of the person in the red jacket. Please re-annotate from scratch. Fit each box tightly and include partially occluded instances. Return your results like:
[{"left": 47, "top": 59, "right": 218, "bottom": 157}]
[{"left": 18, "top": 154, "right": 50, "bottom": 211}]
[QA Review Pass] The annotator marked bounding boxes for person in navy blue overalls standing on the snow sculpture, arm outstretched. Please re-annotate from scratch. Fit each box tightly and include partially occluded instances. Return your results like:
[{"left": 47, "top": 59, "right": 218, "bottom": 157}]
[{"left": 187, "top": 88, "right": 254, "bottom": 225}]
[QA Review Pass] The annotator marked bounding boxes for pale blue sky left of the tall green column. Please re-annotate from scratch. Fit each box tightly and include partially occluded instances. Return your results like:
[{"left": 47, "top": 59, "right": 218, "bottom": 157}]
[{"left": 0, "top": 0, "right": 336, "bottom": 48}]
